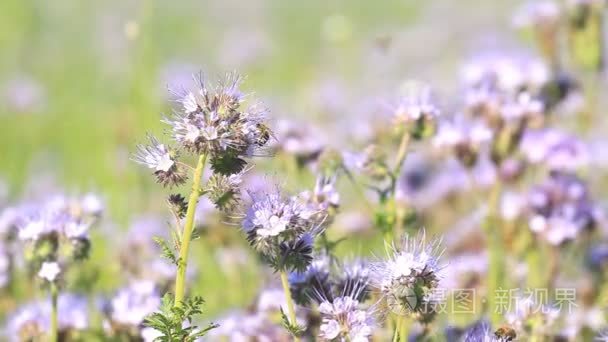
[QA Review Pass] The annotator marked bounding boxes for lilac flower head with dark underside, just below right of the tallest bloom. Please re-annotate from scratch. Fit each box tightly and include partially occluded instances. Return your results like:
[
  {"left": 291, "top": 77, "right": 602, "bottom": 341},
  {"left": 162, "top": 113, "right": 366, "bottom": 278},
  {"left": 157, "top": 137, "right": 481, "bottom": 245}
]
[{"left": 242, "top": 189, "right": 325, "bottom": 271}]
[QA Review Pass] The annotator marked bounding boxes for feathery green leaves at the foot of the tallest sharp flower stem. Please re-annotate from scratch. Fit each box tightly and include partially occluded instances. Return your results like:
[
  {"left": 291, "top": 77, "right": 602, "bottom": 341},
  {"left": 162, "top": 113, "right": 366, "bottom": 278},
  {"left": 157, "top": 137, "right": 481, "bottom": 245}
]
[{"left": 144, "top": 293, "right": 218, "bottom": 342}]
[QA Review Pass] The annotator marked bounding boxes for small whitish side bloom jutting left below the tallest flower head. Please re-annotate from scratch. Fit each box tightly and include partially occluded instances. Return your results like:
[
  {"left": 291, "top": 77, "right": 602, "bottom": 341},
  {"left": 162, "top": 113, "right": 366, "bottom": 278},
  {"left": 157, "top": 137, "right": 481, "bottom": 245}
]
[{"left": 133, "top": 135, "right": 186, "bottom": 186}]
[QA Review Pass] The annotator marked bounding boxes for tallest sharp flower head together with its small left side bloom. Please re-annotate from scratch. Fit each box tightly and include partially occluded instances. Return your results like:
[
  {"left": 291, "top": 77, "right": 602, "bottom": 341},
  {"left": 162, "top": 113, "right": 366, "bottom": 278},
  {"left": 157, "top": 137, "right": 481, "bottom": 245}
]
[{"left": 133, "top": 74, "right": 272, "bottom": 187}]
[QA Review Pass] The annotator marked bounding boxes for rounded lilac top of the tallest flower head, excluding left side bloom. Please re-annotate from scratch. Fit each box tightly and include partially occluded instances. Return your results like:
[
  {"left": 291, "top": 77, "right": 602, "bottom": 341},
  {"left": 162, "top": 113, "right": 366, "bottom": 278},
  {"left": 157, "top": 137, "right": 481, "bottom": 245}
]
[{"left": 163, "top": 74, "right": 271, "bottom": 159}]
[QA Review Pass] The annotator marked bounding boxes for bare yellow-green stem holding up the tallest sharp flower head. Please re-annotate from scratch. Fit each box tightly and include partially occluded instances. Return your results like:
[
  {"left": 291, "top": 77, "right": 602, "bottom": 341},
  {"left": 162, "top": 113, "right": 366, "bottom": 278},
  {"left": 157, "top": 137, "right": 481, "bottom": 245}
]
[{"left": 174, "top": 154, "right": 207, "bottom": 306}]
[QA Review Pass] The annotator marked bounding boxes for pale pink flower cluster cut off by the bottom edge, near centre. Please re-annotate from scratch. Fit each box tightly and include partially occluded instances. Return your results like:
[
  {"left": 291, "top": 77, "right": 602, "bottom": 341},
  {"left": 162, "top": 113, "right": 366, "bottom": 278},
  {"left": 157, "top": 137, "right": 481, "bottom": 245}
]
[{"left": 319, "top": 289, "right": 376, "bottom": 342}]
